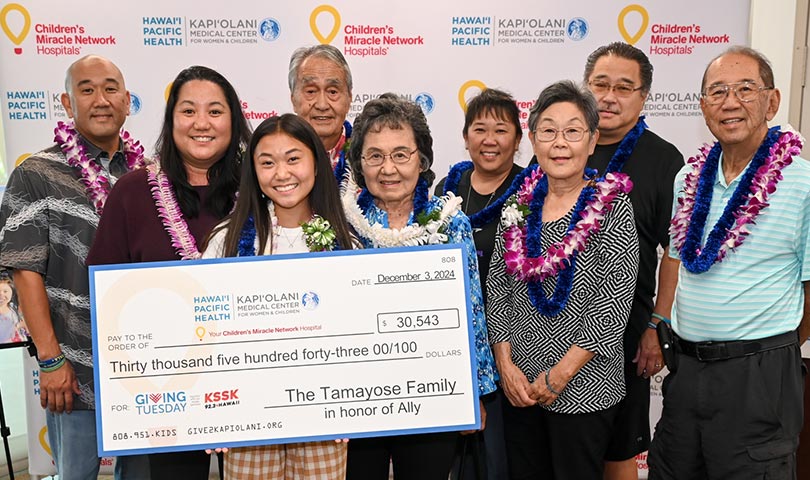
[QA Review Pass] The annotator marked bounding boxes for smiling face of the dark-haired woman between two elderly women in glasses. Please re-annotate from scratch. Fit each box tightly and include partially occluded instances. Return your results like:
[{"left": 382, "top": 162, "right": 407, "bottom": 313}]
[{"left": 464, "top": 115, "right": 520, "bottom": 175}]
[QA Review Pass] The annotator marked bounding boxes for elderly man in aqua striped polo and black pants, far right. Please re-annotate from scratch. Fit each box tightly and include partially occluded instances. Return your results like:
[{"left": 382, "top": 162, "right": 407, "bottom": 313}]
[{"left": 648, "top": 47, "right": 810, "bottom": 480}]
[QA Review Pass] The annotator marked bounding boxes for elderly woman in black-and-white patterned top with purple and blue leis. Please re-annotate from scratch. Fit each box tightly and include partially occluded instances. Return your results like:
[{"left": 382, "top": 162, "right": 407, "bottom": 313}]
[{"left": 487, "top": 81, "right": 638, "bottom": 479}]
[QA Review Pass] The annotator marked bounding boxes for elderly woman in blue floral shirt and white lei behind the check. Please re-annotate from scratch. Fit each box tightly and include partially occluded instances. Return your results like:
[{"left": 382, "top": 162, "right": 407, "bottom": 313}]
[{"left": 342, "top": 94, "right": 495, "bottom": 480}]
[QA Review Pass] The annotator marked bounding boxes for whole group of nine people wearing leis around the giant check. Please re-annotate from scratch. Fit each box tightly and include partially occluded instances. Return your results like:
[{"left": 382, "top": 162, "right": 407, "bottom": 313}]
[{"left": 0, "top": 38, "right": 810, "bottom": 480}]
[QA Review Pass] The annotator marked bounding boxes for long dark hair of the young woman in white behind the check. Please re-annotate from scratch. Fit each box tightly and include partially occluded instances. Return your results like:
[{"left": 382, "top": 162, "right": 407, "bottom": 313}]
[{"left": 203, "top": 113, "right": 354, "bottom": 257}]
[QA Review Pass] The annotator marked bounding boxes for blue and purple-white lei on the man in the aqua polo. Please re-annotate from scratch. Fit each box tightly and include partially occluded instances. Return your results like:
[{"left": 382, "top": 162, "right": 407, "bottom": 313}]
[{"left": 669, "top": 127, "right": 803, "bottom": 273}]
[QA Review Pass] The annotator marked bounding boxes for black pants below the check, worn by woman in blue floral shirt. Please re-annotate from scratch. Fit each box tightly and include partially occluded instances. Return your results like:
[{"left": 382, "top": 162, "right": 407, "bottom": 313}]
[{"left": 346, "top": 432, "right": 459, "bottom": 480}]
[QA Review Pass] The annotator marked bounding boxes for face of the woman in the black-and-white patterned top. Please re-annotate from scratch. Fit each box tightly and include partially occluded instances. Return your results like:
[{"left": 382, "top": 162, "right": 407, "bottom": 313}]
[{"left": 530, "top": 102, "right": 599, "bottom": 181}]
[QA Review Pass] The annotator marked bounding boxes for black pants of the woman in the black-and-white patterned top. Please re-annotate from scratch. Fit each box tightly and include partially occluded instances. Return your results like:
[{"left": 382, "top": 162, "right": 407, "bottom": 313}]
[{"left": 503, "top": 401, "right": 618, "bottom": 480}]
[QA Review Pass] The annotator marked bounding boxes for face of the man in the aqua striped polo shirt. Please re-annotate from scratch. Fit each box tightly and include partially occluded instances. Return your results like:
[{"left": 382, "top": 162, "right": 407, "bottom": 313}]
[{"left": 700, "top": 53, "right": 780, "bottom": 154}]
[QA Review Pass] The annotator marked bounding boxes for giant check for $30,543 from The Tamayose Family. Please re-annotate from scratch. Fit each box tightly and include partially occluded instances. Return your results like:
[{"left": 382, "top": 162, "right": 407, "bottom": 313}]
[{"left": 90, "top": 245, "right": 479, "bottom": 455}]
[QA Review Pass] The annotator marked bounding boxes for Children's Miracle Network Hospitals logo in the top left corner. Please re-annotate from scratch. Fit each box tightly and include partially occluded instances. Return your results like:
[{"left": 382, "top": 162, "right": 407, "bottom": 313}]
[{"left": 0, "top": 3, "right": 118, "bottom": 57}]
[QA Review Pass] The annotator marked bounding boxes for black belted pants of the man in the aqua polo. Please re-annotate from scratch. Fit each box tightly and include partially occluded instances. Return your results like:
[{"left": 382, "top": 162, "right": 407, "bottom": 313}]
[{"left": 647, "top": 345, "right": 804, "bottom": 480}]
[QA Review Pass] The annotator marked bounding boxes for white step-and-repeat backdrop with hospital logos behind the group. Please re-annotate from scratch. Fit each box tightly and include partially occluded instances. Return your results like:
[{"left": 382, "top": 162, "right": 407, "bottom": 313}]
[{"left": 0, "top": 0, "right": 749, "bottom": 475}]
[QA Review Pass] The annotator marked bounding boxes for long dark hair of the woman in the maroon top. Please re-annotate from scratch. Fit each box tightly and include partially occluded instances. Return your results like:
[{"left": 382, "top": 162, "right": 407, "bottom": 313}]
[{"left": 155, "top": 66, "right": 250, "bottom": 218}]
